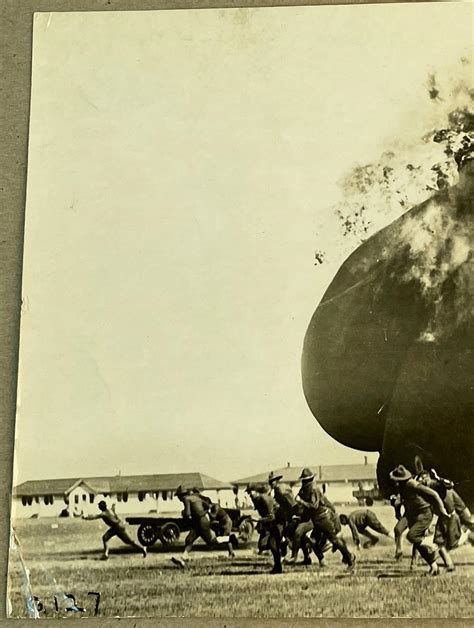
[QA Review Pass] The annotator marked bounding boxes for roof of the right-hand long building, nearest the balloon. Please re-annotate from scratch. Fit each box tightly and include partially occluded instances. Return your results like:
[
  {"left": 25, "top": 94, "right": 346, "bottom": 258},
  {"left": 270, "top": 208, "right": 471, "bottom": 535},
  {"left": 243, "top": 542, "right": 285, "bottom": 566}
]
[{"left": 231, "top": 463, "right": 377, "bottom": 486}]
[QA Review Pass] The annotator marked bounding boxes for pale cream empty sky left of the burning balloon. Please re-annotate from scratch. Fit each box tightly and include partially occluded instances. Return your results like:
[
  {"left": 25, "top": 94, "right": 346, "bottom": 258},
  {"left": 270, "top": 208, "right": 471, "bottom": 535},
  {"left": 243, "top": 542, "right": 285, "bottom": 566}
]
[{"left": 15, "top": 3, "right": 472, "bottom": 482}]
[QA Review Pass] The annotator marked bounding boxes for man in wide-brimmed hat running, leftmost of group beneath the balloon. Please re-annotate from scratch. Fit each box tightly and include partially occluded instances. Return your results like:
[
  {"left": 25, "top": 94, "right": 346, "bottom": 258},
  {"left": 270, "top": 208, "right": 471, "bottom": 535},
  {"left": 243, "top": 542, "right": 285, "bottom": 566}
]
[{"left": 389, "top": 465, "right": 449, "bottom": 576}]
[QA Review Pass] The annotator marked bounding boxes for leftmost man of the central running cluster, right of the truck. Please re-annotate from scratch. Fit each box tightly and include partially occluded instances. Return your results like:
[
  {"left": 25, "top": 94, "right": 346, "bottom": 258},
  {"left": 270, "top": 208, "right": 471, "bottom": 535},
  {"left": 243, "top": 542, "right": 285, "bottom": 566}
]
[{"left": 246, "top": 484, "right": 283, "bottom": 574}]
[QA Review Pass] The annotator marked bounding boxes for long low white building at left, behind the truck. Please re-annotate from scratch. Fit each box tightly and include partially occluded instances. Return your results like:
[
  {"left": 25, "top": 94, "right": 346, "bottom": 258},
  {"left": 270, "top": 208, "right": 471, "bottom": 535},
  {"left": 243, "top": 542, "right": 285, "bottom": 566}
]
[{"left": 12, "top": 473, "right": 235, "bottom": 517}]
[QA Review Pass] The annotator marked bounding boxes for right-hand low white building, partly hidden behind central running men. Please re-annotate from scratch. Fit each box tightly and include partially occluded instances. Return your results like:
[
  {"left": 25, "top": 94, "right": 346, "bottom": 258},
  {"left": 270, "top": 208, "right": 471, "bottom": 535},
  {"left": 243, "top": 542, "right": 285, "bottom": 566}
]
[{"left": 231, "top": 458, "right": 378, "bottom": 505}]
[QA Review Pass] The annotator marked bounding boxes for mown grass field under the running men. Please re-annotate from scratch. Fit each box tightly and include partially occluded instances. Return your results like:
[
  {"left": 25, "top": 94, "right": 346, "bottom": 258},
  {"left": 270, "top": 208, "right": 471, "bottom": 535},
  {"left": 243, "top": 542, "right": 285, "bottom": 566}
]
[{"left": 10, "top": 507, "right": 474, "bottom": 617}]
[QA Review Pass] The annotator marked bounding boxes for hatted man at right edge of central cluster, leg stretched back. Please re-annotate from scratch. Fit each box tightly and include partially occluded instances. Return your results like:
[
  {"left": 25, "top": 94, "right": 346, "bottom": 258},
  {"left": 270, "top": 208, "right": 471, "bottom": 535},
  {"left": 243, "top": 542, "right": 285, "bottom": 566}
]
[{"left": 297, "top": 468, "right": 356, "bottom": 568}]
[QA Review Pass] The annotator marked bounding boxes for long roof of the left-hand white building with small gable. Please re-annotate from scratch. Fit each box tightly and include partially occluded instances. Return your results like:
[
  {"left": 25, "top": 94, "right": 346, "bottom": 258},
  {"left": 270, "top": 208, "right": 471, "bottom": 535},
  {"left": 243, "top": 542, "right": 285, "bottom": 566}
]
[{"left": 13, "top": 473, "right": 232, "bottom": 497}]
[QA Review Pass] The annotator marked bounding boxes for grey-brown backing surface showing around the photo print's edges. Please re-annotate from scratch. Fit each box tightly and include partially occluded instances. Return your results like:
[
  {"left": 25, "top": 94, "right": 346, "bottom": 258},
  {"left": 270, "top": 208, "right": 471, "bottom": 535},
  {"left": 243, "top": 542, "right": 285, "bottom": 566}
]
[{"left": 0, "top": 0, "right": 456, "bottom": 626}]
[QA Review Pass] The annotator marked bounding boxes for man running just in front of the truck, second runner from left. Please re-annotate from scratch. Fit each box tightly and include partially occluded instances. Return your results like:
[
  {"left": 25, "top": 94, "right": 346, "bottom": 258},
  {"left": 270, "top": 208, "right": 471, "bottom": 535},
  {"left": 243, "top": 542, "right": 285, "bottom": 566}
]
[{"left": 171, "top": 486, "right": 218, "bottom": 567}]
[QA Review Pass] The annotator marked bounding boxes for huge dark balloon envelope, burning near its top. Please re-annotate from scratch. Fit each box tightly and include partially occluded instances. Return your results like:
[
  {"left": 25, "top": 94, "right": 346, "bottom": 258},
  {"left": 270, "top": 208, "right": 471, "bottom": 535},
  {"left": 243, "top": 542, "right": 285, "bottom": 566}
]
[{"left": 302, "top": 166, "right": 474, "bottom": 505}]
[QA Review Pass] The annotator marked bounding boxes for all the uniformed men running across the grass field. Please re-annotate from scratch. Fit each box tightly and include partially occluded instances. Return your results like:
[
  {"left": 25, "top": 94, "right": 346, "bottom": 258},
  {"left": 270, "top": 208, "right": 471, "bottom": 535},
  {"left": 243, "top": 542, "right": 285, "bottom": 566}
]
[{"left": 86, "top": 458, "right": 474, "bottom": 575}]
